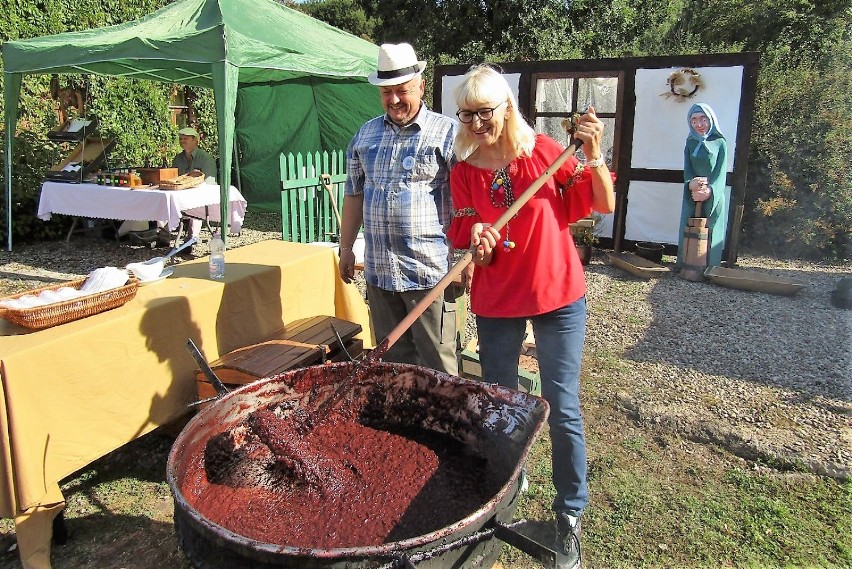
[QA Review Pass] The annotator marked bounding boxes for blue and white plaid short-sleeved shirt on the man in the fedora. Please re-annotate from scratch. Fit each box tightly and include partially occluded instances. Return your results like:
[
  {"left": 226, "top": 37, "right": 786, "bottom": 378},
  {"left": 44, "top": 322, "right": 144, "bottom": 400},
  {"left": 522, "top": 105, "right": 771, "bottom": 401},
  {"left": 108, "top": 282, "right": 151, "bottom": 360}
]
[{"left": 345, "top": 105, "right": 456, "bottom": 291}]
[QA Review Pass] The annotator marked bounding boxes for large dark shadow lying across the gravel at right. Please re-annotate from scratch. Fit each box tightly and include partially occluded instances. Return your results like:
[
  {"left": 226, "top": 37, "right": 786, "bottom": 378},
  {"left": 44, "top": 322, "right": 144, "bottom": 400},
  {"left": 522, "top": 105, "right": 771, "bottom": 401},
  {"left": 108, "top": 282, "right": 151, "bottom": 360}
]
[{"left": 590, "top": 264, "right": 852, "bottom": 402}]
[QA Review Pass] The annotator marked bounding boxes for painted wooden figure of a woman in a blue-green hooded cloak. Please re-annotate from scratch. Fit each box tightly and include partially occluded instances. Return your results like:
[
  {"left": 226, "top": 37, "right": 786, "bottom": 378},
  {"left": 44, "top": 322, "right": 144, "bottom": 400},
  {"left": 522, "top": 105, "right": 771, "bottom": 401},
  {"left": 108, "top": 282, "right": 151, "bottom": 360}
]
[{"left": 677, "top": 103, "right": 728, "bottom": 267}]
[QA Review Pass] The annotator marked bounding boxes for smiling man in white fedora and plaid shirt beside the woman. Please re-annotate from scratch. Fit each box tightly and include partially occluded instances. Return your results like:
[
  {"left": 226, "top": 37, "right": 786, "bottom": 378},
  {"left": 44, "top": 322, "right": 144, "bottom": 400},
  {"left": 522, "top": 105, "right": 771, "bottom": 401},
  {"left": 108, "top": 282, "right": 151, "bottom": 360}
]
[{"left": 340, "top": 43, "right": 458, "bottom": 375}]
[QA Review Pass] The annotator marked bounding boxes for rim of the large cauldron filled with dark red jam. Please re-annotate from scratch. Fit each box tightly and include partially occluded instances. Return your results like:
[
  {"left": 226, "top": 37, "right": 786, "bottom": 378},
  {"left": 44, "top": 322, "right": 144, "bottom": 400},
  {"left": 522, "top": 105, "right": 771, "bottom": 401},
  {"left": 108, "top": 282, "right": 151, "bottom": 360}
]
[{"left": 166, "top": 362, "right": 549, "bottom": 559}]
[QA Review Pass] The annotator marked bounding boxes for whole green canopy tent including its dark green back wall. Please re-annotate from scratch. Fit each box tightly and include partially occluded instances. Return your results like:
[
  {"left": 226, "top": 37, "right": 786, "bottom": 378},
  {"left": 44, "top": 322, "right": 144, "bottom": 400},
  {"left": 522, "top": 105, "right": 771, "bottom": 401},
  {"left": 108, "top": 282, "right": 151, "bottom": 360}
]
[{"left": 3, "top": 0, "right": 381, "bottom": 250}]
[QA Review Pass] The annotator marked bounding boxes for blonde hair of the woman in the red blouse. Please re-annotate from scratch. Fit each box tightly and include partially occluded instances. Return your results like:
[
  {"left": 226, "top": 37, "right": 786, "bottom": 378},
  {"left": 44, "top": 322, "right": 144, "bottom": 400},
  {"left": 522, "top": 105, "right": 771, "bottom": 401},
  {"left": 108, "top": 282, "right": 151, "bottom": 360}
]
[{"left": 454, "top": 64, "right": 535, "bottom": 160}]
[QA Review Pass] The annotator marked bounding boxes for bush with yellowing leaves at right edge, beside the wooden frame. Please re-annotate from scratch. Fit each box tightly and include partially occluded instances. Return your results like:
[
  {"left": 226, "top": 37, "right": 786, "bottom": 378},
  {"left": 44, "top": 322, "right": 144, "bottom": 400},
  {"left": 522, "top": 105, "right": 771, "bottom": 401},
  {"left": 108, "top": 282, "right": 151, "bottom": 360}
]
[{"left": 743, "top": 45, "right": 852, "bottom": 260}]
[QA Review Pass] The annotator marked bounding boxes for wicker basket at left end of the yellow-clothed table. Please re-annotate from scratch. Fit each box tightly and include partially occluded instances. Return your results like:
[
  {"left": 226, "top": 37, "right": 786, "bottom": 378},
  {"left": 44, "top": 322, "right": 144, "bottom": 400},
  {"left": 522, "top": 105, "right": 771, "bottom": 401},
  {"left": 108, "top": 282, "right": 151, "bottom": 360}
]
[{"left": 0, "top": 276, "right": 139, "bottom": 330}]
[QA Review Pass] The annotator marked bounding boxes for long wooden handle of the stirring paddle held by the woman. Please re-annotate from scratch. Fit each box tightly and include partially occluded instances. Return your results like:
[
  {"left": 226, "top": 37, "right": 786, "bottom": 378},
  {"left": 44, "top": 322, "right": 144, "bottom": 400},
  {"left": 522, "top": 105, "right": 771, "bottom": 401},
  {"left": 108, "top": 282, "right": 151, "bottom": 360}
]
[{"left": 367, "top": 139, "right": 583, "bottom": 359}]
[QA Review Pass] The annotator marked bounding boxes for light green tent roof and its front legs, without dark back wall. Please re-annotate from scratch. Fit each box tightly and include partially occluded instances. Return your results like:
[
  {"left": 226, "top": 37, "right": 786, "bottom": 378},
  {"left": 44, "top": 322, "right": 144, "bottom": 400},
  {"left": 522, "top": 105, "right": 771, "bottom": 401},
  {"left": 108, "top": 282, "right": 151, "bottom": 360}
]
[{"left": 2, "top": 0, "right": 378, "bottom": 251}]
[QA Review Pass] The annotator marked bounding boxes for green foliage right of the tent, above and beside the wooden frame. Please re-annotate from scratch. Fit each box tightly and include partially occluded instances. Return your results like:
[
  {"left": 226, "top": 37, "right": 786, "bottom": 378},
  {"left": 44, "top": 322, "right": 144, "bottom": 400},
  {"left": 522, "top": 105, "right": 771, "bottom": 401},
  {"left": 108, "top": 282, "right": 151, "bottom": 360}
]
[{"left": 342, "top": 0, "right": 852, "bottom": 259}]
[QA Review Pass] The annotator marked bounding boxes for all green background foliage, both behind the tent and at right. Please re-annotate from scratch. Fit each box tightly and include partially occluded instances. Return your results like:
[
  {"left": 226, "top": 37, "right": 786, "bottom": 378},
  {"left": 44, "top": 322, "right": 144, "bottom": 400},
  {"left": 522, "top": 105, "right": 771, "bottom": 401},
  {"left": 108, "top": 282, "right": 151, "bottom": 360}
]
[{"left": 0, "top": 0, "right": 852, "bottom": 255}]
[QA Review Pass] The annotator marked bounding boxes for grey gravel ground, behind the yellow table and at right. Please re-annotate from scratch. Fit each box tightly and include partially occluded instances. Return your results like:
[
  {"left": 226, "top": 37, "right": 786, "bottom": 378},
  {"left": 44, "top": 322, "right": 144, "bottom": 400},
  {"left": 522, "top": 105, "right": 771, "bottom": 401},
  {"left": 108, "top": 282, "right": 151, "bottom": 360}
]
[{"left": 0, "top": 213, "right": 852, "bottom": 478}]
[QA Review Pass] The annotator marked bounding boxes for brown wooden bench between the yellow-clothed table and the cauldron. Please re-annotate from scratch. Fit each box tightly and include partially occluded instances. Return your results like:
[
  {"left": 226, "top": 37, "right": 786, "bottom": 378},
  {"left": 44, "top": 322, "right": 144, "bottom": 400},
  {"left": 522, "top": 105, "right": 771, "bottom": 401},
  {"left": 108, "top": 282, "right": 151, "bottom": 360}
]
[{"left": 195, "top": 316, "right": 364, "bottom": 400}]
